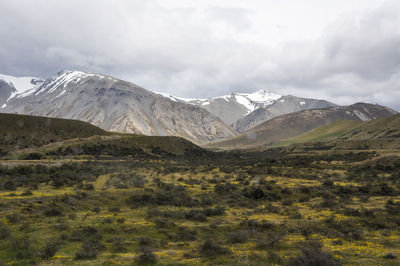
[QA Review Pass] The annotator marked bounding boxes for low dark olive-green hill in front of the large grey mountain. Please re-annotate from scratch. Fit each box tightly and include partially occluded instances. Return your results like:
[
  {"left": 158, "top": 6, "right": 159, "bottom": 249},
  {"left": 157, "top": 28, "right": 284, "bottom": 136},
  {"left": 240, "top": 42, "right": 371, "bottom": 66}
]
[{"left": 0, "top": 111, "right": 211, "bottom": 157}]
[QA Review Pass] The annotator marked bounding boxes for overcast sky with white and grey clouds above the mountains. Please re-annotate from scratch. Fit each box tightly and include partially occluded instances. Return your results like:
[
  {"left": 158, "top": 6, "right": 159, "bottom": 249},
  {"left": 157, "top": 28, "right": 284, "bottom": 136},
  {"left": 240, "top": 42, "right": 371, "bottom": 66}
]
[{"left": 0, "top": 0, "right": 400, "bottom": 110}]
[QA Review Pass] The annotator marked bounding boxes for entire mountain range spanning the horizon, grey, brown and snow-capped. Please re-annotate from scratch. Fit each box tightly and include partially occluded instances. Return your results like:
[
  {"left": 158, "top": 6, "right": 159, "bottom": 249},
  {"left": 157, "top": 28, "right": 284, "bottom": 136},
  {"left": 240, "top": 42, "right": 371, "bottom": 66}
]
[{"left": 0, "top": 70, "right": 396, "bottom": 147}]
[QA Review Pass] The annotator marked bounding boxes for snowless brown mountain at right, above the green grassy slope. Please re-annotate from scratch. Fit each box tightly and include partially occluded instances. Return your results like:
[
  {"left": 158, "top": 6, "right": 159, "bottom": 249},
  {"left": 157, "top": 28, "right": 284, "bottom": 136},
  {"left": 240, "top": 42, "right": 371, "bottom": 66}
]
[{"left": 210, "top": 103, "right": 397, "bottom": 149}]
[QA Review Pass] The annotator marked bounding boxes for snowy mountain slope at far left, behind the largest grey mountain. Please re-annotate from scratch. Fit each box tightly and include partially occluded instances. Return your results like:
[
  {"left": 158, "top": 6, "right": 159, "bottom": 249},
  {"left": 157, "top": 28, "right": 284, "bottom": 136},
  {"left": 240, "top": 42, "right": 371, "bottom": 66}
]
[{"left": 0, "top": 74, "right": 44, "bottom": 107}]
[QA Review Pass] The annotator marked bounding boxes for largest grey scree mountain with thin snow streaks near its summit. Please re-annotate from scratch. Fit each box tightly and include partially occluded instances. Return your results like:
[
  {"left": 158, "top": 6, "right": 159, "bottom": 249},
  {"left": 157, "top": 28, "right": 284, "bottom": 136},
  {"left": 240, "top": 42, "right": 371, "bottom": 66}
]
[{"left": 0, "top": 71, "right": 236, "bottom": 143}]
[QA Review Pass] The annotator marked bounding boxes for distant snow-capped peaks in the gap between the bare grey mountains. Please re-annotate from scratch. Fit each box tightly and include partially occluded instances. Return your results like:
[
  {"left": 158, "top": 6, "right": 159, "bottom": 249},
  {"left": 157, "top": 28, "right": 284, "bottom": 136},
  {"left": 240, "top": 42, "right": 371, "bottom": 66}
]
[{"left": 159, "top": 90, "right": 281, "bottom": 125}]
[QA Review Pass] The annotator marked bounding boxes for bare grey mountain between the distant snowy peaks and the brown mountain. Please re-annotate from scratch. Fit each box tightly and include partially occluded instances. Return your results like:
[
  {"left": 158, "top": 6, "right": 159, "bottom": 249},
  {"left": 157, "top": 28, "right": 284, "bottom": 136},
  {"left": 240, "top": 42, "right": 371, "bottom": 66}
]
[{"left": 234, "top": 95, "right": 337, "bottom": 133}]
